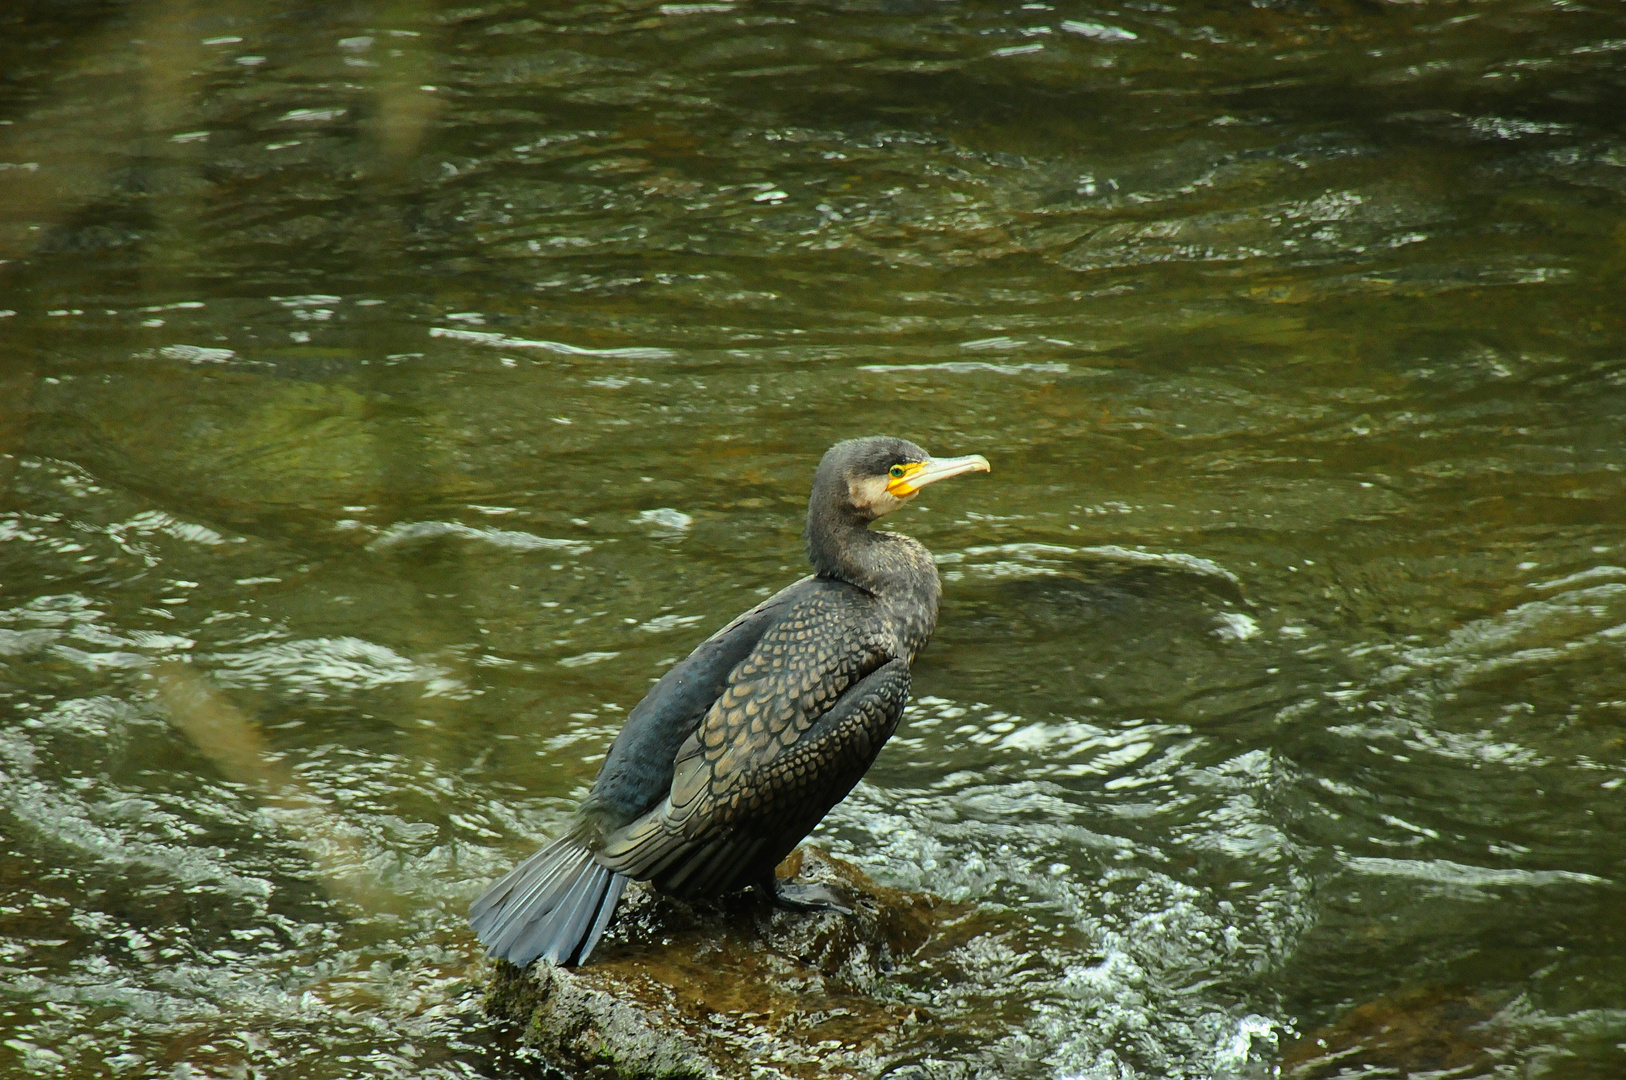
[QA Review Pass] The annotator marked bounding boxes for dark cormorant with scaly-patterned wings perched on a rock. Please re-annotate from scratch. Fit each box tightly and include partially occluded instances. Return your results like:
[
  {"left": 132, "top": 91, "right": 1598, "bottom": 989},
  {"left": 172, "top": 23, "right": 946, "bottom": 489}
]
[{"left": 468, "top": 438, "right": 989, "bottom": 965}]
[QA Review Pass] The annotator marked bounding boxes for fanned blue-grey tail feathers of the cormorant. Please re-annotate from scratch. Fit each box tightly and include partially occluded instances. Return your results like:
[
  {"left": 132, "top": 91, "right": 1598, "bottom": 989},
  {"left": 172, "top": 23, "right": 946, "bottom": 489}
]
[{"left": 468, "top": 836, "right": 626, "bottom": 966}]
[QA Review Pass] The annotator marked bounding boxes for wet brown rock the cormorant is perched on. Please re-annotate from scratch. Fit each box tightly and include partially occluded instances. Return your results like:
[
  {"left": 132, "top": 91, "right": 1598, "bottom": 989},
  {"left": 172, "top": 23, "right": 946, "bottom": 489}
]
[{"left": 486, "top": 847, "right": 976, "bottom": 1080}]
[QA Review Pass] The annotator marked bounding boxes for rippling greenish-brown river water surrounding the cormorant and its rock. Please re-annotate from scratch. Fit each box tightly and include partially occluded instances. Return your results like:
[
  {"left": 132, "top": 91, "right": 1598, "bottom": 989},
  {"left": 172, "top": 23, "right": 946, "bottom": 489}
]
[{"left": 0, "top": 0, "right": 1626, "bottom": 1080}]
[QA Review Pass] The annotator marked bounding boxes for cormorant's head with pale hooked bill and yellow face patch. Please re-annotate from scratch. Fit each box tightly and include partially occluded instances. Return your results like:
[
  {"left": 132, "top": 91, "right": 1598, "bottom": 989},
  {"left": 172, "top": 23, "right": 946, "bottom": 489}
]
[{"left": 808, "top": 436, "right": 989, "bottom": 522}]
